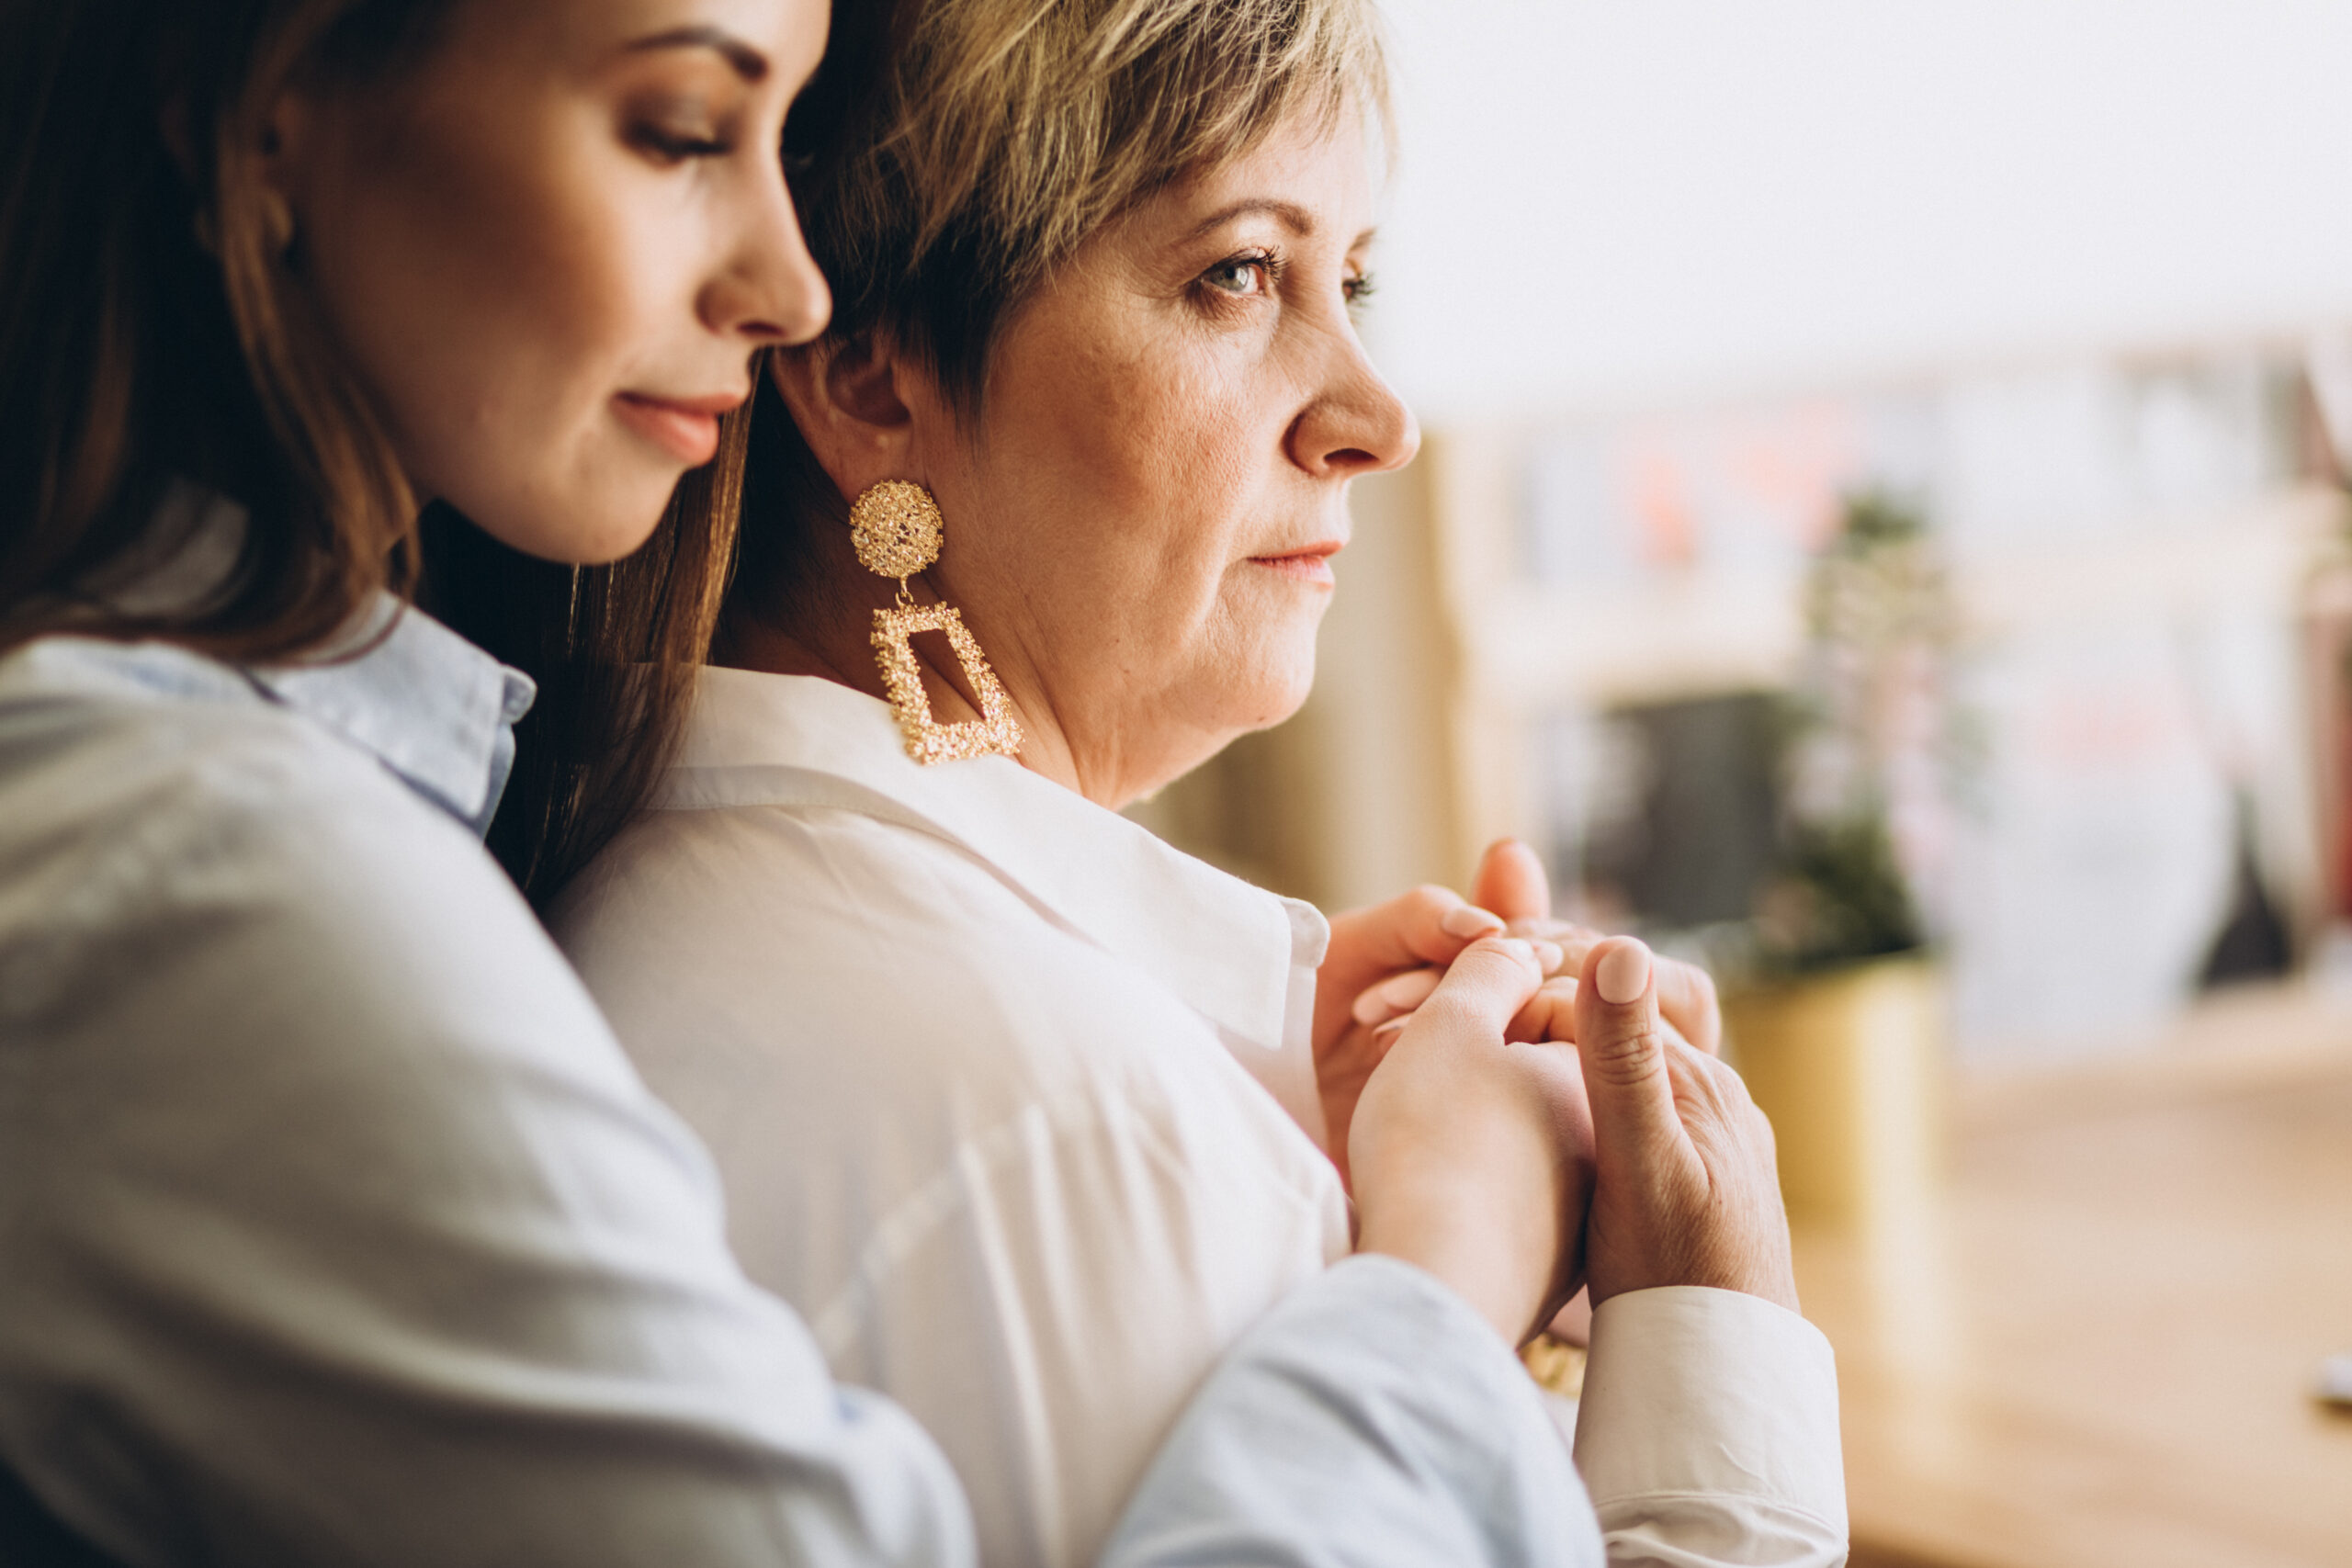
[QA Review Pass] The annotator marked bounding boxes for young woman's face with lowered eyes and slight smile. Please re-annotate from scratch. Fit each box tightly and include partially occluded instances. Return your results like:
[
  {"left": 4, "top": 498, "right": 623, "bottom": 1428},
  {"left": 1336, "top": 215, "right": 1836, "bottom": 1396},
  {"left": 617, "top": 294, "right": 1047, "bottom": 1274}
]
[{"left": 273, "top": 0, "right": 831, "bottom": 562}]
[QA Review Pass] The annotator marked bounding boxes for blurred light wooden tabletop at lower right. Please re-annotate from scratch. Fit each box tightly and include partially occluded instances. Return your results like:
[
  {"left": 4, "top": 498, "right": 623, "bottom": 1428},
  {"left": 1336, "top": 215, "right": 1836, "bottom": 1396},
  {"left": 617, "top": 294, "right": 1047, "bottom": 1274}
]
[{"left": 1797, "top": 989, "right": 2352, "bottom": 1568}]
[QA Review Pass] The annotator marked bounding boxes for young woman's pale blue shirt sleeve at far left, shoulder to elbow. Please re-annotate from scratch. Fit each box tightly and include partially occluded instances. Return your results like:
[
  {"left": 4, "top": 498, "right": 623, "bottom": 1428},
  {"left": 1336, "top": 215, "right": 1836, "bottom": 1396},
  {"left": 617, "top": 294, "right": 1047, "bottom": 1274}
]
[{"left": 0, "top": 719, "right": 971, "bottom": 1568}]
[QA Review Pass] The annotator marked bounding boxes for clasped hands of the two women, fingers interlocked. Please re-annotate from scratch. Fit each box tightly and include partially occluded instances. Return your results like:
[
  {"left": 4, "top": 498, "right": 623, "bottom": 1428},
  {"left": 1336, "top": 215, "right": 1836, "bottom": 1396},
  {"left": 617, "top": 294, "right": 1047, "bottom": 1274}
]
[{"left": 1315, "top": 844, "right": 1797, "bottom": 1342}]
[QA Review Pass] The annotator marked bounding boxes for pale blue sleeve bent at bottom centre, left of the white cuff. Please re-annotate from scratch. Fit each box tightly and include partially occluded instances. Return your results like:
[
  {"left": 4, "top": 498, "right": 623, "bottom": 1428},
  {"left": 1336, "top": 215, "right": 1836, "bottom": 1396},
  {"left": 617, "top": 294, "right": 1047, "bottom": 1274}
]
[{"left": 1103, "top": 1256, "right": 1601, "bottom": 1568}]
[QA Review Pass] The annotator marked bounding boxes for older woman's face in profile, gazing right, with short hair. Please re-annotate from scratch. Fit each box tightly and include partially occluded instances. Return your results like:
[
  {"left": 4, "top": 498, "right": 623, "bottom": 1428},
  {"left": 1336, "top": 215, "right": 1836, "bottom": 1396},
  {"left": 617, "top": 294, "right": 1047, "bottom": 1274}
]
[{"left": 917, "top": 115, "right": 1420, "bottom": 804}]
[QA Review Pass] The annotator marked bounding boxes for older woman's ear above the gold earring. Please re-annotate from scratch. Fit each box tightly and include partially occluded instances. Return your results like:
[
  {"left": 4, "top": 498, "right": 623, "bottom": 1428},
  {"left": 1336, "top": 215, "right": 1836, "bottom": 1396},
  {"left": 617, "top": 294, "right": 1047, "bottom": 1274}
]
[{"left": 767, "top": 333, "right": 936, "bottom": 499}]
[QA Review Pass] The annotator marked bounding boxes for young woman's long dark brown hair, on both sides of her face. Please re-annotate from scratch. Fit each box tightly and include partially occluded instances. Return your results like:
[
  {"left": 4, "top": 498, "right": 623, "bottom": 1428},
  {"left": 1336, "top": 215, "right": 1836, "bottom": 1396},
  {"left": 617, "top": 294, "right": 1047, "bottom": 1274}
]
[{"left": 0, "top": 0, "right": 748, "bottom": 896}]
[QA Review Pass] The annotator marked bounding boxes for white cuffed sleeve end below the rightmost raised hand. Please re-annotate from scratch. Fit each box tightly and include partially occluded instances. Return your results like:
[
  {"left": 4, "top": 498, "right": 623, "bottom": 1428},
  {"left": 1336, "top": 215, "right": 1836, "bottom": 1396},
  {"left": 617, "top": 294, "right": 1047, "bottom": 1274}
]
[{"left": 1576, "top": 1286, "right": 1847, "bottom": 1568}]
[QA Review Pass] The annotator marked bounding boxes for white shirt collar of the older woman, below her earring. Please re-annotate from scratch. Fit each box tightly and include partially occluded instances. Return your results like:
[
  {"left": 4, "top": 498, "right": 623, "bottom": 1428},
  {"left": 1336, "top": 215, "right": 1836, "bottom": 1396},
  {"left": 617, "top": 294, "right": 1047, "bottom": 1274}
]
[{"left": 654, "top": 668, "right": 1331, "bottom": 1051}]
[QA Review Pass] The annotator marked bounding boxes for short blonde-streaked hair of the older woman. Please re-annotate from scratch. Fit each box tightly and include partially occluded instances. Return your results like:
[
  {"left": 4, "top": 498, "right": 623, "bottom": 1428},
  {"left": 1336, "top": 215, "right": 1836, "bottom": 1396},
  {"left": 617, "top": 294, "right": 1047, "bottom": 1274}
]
[{"left": 786, "top": 0, "right": 1387, "bottom": 402}]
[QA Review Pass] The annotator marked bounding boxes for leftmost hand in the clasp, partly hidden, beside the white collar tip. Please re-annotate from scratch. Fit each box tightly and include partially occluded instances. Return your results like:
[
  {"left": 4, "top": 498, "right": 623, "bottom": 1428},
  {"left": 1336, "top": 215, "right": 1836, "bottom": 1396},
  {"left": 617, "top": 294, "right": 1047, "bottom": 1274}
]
[{"left": 1315, "top": 886, "right": 1562, "bottom": 1182}]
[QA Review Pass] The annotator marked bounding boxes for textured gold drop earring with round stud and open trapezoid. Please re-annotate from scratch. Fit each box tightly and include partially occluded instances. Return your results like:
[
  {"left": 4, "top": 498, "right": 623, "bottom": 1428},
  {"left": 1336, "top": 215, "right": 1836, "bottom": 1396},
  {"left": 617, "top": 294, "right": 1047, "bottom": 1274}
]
[{"left": 849, "top": 479, "right": 1021, "bottom": 766}]
